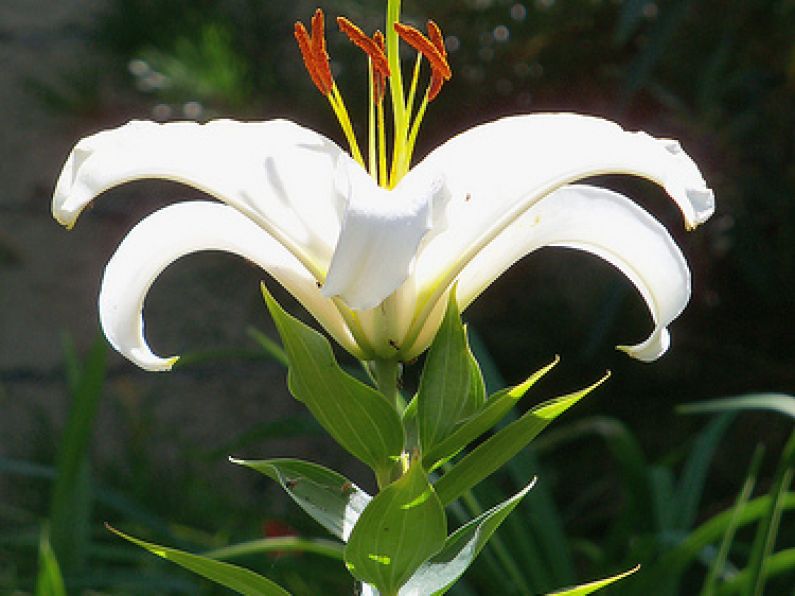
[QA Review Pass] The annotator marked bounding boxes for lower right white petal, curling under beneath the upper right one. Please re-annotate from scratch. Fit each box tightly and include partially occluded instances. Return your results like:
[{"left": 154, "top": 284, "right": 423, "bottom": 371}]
[{"left": 457, "top": 185, "right": 690, "bottom": 362}]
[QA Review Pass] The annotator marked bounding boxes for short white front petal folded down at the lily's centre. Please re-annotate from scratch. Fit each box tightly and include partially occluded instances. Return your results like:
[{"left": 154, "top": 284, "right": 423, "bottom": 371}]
[{"left": 323, "top": 158, "right": 442, "bottom": 310}]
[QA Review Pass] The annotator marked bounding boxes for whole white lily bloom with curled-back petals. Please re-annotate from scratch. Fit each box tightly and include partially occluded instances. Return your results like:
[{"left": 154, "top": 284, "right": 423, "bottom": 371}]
[{"left": 52, "top": 11, "right": 714, "bottom": 370}]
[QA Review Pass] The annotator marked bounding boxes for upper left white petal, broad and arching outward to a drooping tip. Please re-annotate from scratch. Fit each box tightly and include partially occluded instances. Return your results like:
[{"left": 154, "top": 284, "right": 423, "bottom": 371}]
[{"left": 52, "top": 120, "right": 350, "bottom": 277}]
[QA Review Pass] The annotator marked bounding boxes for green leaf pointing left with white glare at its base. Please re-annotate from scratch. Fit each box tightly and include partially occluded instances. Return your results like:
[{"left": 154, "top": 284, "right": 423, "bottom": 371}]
[{"left": 231, "top": 459, "right": 372, "bottom": 541}]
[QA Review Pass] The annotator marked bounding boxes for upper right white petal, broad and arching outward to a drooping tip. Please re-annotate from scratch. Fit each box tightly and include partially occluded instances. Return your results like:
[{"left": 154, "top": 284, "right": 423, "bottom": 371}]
[{"left": 404, "top": 114, "right": 714, "bottom": 294}]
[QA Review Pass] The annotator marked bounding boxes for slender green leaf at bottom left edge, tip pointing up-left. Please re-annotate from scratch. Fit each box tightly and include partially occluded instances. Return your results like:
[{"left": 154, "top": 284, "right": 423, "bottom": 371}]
[{"left": 106, "top": 525, "right": 290, "bottom": 596}]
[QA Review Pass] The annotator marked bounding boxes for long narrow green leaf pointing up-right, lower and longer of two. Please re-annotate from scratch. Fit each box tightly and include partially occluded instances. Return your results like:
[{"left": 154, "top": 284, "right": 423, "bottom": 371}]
[{"left": 434, "top": 373, "right": 610, "bottom": 505}]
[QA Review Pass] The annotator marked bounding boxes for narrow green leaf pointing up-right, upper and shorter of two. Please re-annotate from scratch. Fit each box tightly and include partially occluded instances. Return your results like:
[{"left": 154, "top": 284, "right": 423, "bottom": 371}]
[{"left": 422, "top": 356, "right": 560, "bottom": 471}]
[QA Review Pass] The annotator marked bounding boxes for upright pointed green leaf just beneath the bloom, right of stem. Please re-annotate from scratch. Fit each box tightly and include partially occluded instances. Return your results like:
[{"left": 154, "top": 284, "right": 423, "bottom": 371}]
[{"left": 417, "top": 290, "right": 485, "bottom": 451}]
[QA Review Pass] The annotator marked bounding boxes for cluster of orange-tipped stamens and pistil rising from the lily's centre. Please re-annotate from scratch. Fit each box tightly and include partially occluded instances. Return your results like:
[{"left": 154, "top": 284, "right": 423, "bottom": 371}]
[{"left": 295, "top": 0, "right": 452, "bottom": 188}]
